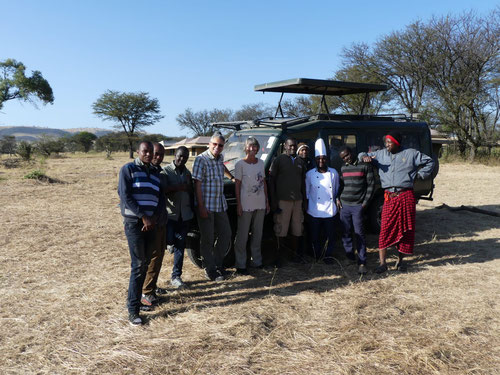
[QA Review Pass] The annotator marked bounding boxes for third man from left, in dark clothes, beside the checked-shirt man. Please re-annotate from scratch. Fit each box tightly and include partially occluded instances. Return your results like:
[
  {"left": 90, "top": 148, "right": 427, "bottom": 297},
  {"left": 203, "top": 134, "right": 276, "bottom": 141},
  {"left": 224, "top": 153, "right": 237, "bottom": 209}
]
[{"left": 165, "top": 146, "right": 194, "bottom": 288}]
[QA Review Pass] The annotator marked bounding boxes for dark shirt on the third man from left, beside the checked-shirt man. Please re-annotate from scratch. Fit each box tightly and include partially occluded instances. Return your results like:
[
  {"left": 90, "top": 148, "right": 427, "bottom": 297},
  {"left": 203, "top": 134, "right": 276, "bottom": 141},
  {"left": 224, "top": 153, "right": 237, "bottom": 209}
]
[{"left": 164, "top": 162, "right": 194, "bottom": 221}]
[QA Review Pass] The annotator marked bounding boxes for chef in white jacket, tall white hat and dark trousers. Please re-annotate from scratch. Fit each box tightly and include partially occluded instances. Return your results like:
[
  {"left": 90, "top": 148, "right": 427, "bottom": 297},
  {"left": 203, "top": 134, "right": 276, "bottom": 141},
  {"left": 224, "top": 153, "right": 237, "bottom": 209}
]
[{"left": 306, "top": 138, "right": 339, "bottom": 264}]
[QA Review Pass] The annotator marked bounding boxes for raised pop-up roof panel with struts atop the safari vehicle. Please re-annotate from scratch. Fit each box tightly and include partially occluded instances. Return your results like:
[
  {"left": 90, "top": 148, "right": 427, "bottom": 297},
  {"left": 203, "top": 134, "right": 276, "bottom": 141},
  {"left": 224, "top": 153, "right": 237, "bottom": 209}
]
[{"left": 254, "top": 78, "right": 389, "bottom": 117}]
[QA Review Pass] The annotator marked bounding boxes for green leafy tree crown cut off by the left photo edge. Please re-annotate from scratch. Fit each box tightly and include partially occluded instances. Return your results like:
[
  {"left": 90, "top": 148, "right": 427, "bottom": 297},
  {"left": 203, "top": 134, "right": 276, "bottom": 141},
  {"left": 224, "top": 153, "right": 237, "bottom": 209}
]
[{"left": 0, "top": 59, "right": 54, "bottom": 109}]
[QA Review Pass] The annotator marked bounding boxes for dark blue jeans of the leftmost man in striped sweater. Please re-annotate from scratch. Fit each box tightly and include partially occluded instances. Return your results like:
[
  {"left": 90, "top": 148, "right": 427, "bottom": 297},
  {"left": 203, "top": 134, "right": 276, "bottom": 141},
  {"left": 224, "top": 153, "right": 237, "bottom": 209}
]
[{"left": 124, "top": 221, "right": 157, "bottom": 314}]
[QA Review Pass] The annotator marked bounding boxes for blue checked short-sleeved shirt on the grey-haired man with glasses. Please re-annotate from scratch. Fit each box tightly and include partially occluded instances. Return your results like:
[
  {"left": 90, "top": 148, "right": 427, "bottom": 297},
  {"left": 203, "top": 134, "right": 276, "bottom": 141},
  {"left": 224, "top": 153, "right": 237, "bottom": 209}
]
[{"left": 193, "top": 150, "right": 227, "bottom": 212}]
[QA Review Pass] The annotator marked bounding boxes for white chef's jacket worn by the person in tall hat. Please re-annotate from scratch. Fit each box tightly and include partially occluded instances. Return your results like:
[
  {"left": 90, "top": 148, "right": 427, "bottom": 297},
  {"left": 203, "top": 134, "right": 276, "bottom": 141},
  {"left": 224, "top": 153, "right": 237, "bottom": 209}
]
[{"left": 306, "top": 168, "right": 339, "bottom": 218}]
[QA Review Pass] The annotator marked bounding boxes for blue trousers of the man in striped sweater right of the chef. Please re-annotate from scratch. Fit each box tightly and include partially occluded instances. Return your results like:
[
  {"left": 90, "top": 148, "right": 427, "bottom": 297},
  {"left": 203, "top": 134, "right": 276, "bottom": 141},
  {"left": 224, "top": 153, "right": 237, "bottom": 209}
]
[{"left": 340, "top": 204, "right": 366, "bottom": 264}]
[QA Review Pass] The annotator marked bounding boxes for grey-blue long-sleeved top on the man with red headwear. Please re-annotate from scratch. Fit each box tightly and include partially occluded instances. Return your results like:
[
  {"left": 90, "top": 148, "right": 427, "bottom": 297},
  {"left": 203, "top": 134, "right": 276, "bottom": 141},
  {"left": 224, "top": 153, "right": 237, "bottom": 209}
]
[{"left": 358, "top": 148, "right": 434, "bottom": 189}]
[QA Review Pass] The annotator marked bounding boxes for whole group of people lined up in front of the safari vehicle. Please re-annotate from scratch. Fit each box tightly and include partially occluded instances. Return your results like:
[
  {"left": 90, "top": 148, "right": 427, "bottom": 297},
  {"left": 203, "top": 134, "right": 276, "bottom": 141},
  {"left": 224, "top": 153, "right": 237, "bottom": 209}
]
[{"left": 118, "top": 132, "right": 433, "bottom": 325}]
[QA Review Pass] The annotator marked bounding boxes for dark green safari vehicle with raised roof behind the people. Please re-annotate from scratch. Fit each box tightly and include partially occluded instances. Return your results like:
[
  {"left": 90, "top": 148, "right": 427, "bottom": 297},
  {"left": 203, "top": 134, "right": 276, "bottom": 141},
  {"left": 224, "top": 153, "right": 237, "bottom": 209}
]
[{"left": 187, "top": 78, "right": 438, "bottom": 266}]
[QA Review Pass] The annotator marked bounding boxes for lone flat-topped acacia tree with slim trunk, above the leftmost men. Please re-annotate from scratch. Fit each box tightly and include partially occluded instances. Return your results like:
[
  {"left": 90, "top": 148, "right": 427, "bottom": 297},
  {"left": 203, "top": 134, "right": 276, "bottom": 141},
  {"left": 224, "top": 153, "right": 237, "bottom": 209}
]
[{"left": 92, "top": 90, "right": 164, "bottom": 158}]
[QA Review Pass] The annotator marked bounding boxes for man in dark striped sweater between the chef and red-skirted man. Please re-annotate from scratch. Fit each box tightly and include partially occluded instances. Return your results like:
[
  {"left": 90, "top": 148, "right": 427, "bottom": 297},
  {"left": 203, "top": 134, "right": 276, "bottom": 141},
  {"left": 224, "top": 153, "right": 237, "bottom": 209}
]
[{"left": 337, "top": 147, "right": 375, "bottom": 275}]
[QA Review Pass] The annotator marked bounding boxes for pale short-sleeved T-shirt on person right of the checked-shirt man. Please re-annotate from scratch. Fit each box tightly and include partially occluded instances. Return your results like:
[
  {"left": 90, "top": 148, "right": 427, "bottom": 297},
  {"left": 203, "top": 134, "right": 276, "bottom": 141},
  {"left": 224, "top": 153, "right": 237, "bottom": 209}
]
[{"left": 234, "top": 159, "right": 266, "bottom": 211}]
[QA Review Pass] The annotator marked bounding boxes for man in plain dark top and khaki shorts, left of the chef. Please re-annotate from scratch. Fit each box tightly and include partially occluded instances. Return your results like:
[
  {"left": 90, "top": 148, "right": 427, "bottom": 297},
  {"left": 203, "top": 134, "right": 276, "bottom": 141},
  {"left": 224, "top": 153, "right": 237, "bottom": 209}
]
[{"left": 269, "top": 137, "right": 306, "bottom": 266}]
